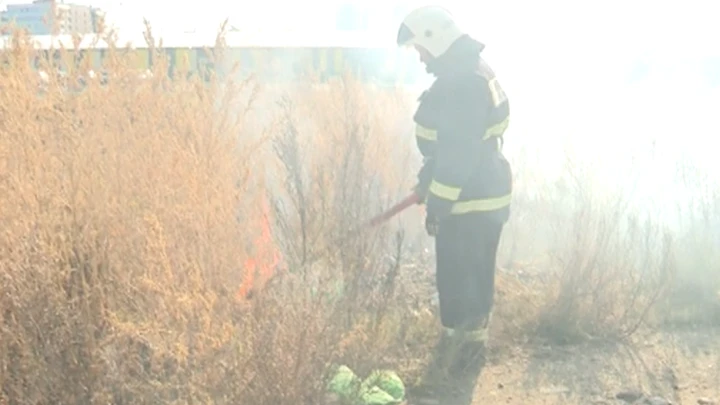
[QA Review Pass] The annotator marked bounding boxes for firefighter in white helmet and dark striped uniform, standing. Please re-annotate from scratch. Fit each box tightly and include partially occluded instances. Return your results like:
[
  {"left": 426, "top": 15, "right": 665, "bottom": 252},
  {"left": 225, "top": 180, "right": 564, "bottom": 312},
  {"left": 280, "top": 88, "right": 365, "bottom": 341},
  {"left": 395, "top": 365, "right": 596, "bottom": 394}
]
[{"left": 397, "top": 6, "right": 512, "bottom": 367}]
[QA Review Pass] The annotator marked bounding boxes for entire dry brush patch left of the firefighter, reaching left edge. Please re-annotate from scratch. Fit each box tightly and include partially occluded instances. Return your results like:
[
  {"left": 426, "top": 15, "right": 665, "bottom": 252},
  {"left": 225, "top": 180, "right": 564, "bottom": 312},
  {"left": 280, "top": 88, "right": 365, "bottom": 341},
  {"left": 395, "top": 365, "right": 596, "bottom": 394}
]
[{"left": 0, "top": 29, "right": 432, "bottom": 404}]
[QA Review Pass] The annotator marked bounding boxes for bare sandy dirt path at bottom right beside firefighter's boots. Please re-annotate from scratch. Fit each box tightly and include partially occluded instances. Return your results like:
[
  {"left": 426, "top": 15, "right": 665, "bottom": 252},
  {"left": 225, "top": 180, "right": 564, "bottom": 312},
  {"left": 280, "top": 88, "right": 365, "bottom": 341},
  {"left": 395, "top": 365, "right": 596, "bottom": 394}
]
[{"left": 472, "top": 328, "right": 720, "bottom": 405}]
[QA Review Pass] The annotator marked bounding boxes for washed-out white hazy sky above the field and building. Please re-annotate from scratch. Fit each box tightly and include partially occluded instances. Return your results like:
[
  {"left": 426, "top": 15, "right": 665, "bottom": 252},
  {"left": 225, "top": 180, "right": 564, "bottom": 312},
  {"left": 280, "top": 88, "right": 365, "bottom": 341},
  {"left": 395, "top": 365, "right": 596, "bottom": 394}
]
[{"left": 2, "top": 0, "right": 720, "bottom": 188}]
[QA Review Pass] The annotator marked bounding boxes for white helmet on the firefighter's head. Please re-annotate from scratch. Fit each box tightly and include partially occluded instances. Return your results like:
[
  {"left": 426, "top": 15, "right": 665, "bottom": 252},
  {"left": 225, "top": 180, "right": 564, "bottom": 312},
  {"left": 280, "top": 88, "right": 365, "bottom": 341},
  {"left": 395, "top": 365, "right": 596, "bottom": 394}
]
[{"left": 397, "top": 6, "right": 465, "bottom": 58}]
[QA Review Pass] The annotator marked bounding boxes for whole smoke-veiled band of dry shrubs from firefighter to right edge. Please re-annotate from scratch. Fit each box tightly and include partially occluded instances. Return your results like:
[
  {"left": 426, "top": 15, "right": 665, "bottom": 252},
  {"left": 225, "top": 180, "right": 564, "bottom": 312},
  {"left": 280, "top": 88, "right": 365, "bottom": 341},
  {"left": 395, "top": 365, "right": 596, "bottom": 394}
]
[{"left": 495, "top": 141, "right": 720, "bottom": 344}]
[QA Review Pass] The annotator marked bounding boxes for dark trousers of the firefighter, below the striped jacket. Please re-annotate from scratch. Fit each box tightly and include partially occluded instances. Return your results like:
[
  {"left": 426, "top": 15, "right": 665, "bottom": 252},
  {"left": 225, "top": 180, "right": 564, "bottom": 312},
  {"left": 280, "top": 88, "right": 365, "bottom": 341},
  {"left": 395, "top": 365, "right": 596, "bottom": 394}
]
[{"left": 435, "top": 213, "right": 504, "bottom": 331}]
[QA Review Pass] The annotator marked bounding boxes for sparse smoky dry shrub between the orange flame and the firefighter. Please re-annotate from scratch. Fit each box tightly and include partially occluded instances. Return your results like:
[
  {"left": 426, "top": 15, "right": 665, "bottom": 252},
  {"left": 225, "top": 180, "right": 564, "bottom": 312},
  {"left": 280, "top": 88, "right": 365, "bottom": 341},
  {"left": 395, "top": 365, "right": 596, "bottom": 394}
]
[{"left": 256, "top": 76, "right": 438, "bottom": 382}]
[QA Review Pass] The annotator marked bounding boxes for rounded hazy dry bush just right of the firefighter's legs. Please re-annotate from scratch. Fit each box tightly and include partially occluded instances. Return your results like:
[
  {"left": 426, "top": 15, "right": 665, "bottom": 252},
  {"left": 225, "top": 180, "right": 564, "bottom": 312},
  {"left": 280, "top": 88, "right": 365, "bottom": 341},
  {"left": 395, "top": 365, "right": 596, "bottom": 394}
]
[{"left": 496, "top": 153, "right": 676, "bottom": 344}]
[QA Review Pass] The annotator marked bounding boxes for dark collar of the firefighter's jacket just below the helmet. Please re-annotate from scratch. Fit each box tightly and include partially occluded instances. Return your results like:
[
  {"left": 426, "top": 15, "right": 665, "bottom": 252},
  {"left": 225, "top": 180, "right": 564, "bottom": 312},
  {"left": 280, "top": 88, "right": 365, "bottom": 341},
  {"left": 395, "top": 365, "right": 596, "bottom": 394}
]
[{"left": 425, "top": 35, "right": 485, "bottom": 78}]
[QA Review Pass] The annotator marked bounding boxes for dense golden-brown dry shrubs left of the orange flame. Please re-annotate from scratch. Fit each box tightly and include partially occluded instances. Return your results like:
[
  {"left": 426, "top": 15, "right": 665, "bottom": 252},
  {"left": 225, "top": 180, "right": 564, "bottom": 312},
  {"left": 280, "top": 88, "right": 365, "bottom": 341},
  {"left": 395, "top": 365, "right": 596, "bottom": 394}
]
[{"left": 0, "top": 26, "right": 260, "bottom": 403}]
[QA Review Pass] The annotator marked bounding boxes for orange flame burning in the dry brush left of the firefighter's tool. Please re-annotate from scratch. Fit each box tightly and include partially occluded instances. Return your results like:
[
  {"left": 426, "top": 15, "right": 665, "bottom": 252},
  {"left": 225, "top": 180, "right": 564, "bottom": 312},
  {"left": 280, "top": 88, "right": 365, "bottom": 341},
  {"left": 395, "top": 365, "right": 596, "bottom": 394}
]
[{"left": 238, "top": 198, "right": 282, "bottom": 299}]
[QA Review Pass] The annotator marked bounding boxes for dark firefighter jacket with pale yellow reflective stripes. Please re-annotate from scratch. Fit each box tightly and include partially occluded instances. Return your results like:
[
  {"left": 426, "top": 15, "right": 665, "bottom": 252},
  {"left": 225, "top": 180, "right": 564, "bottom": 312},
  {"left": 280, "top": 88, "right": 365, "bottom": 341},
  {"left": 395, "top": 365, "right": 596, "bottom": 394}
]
[{"left": 414, "top": 36, "right": 512, "bottom": 222}]
